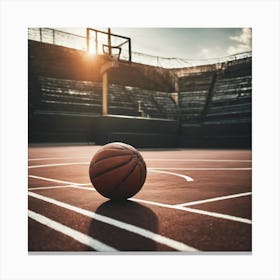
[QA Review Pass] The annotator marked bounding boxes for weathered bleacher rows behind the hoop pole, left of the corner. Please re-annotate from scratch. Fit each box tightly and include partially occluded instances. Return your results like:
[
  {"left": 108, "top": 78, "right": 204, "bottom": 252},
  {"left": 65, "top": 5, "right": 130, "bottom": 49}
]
[{"left": 29, "top": 76, "right": 177, "bottom": 119}]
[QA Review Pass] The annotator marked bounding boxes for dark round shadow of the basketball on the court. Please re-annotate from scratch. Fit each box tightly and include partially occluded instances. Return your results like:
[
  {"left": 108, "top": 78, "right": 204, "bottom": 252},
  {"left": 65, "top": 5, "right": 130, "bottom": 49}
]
[{"left": 89, "top": 200, "right": 158, "bottom": 251}]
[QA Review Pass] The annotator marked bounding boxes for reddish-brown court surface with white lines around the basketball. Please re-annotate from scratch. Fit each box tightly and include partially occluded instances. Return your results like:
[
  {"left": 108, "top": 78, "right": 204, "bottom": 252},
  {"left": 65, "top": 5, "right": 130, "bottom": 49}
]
[{"left": 28, "top": 145, "right": 252, "bottom": 252}]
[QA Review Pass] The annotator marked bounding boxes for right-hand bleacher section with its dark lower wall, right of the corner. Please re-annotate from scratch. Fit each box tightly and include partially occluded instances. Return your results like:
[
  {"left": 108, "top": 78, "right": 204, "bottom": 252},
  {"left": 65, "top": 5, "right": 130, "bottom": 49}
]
[{"left": 179, "top": 58, "right": 252, "bottom": 147}]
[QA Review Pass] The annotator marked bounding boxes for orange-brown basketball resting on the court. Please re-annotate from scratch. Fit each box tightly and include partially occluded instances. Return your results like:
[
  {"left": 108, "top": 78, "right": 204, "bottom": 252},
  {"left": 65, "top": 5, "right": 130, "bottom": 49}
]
[{"left": 89, "top": 142, "right": 147, "bottom": 200}]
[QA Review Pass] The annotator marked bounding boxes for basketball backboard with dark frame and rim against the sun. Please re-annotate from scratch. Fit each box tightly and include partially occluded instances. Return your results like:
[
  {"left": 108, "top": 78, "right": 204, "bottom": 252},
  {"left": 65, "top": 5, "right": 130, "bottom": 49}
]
[{"left": 87, "top": 28, "right": 131, "bottom": 61}]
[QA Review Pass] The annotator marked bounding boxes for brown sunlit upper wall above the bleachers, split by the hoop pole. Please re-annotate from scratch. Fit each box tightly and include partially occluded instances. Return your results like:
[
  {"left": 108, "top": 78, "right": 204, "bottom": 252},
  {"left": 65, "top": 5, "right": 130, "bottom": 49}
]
[{"left": 28, "top": 40, "right": 176, "bottom": 92}]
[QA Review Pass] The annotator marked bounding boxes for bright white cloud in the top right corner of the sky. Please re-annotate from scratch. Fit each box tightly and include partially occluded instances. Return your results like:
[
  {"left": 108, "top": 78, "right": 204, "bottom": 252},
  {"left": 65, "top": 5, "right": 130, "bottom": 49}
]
[{"left": 227, "top": 28, "right": 252, "bottom": 54}]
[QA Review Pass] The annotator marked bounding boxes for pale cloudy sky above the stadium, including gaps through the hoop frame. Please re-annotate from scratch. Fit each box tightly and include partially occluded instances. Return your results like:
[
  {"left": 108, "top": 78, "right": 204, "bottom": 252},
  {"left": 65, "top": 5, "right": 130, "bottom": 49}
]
[{"left": 51, "top": 27, "right": 252, "bottom": 68}]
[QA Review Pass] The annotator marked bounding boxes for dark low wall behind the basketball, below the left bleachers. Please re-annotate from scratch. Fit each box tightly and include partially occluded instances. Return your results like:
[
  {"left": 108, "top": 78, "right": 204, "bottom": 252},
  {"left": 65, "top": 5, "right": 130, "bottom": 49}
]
[{"left": 28, "top": 112, "right": 179, "bottom": 148}]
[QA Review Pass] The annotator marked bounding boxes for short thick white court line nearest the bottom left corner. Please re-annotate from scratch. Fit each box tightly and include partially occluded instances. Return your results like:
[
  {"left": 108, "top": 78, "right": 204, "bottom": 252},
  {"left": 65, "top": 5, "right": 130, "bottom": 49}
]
[{"left": 28, "top": 210, "right": 118, "bottom": 252}]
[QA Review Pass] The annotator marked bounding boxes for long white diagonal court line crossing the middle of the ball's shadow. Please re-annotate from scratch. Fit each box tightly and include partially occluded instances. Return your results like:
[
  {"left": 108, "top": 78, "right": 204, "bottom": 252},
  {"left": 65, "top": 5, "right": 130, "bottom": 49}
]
[{"left": 28, "top": 192, "right": 198, "bottom": 252}]
